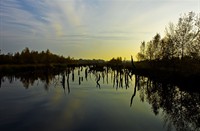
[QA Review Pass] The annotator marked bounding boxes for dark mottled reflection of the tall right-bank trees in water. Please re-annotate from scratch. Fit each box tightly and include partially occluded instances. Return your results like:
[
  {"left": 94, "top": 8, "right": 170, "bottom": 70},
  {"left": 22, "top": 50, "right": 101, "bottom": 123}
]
[{"left": 134, "top": 76, "right": 200, "bottom": 131}]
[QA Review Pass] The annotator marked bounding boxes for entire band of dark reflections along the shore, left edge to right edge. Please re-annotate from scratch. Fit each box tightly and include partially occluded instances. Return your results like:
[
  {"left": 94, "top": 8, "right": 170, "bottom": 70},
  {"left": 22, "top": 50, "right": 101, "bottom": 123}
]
[{"left": 0, "top": 67, "right": 200, "bottom": 131}]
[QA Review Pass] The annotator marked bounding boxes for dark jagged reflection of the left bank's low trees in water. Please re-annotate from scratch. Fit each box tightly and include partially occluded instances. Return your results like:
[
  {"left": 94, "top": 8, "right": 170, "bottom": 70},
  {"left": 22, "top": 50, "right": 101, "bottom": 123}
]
[{"left": 0, "top": 67, "right": 76, "bottom": 94}]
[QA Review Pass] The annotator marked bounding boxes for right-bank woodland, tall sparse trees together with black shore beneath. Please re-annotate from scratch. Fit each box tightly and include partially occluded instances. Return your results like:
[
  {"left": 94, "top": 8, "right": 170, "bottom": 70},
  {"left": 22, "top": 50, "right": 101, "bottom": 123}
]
[{"left": 135, "top": 12, "right": 200, "bottom": 79}]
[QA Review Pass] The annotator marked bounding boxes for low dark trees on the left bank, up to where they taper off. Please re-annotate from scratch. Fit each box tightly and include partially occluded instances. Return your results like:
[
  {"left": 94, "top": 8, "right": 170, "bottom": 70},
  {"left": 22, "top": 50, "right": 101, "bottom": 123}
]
[{"left": 0, "top": 47, "right": 73, "bottom": 64}]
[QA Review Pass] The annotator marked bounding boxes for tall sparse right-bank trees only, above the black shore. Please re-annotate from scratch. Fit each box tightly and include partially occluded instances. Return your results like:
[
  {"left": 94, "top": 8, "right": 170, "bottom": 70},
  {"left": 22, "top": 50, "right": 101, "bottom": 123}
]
[{"left": 137, "top": 12, "right": 200, "bottom": 61}]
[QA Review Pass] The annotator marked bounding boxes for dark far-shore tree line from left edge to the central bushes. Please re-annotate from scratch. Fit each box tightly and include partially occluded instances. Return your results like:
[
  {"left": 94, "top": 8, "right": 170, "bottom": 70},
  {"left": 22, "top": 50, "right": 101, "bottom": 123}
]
[{"left": 0, "top": 47, "right": 130, "bottom": 66}]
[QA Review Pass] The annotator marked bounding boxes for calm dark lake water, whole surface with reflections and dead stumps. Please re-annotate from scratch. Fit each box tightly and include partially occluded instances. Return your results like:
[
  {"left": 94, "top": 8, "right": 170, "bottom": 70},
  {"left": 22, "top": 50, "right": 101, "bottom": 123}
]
[{"left": 0, "top": 67, "right": 200, "bottom": 131}]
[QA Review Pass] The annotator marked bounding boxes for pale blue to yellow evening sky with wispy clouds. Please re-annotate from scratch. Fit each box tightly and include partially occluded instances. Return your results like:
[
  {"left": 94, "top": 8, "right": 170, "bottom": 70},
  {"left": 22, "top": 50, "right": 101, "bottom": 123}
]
[{"left": 0, "top": 0, "right": 200, "bottom": 60}]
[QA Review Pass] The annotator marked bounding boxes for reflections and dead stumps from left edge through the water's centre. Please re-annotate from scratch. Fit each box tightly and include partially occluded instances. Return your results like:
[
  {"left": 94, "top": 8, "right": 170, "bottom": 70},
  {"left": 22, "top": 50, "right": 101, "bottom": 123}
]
[{"left": 0, "top": 67, "right": 132, "bottom": 91}]
